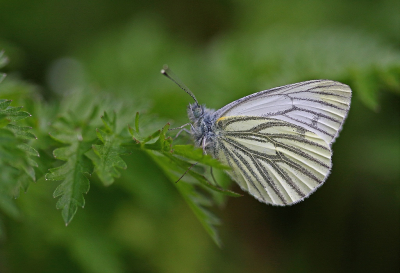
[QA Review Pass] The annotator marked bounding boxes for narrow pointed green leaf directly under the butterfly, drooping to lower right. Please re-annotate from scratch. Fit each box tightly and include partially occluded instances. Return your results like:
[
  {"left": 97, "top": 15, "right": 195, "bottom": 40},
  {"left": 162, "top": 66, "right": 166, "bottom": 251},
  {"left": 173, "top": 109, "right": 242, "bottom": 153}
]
[{"left": 125, "top": 113, "right": 241, "bottom": 245}]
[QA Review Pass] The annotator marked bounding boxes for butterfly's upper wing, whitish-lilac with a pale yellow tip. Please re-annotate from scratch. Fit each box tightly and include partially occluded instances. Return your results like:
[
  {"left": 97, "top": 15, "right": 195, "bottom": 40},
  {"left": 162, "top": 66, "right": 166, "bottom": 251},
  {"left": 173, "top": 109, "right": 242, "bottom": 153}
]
[{"left": 215, "top": 80, "right": 351, "bottom": 144}]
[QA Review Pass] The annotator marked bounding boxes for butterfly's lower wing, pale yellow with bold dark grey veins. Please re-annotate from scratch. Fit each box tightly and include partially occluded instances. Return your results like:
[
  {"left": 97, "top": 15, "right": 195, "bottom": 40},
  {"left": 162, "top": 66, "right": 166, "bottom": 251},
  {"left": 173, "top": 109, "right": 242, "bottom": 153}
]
[{"left": 216, "top": 117, "right": 332, "bottom": 206}]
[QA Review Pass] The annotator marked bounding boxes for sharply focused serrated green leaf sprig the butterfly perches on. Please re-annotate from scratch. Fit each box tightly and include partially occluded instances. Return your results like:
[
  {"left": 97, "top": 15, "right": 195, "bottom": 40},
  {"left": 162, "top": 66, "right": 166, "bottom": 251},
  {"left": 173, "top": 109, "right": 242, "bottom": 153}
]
[{"left": 19, "top": 87, "right": 241, "bottom": 240}]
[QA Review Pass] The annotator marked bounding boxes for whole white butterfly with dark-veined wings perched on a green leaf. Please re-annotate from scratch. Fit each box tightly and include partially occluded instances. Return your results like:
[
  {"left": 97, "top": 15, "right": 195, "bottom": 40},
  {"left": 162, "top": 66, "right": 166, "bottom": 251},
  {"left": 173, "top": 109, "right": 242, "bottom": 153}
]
[{"left": 161, "top": 67, "right": 351, "bottom": 206}]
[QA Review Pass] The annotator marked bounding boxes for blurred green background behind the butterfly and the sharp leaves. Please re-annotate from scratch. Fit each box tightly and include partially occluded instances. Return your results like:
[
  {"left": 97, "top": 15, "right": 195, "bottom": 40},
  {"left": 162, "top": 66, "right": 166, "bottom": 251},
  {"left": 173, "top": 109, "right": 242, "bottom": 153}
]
[{"left": 0, "top": 0, "right": 400, "bottom": 273}]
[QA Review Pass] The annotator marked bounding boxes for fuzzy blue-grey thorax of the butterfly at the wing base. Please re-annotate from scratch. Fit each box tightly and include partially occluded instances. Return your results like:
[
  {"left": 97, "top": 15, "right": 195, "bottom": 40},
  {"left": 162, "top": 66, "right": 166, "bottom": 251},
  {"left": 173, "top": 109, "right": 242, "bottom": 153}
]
[{"left": 187, "top": 103, "right": 216, "bottom": 154}]
